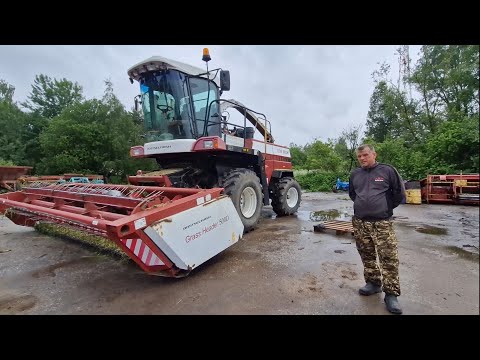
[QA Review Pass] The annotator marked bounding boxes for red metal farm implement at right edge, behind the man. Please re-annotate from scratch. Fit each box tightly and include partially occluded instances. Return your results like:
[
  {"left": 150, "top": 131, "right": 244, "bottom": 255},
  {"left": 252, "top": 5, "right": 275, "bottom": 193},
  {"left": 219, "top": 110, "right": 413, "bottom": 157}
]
[{"left": 420, "top": 174, "right": 480, "bottom": 205}]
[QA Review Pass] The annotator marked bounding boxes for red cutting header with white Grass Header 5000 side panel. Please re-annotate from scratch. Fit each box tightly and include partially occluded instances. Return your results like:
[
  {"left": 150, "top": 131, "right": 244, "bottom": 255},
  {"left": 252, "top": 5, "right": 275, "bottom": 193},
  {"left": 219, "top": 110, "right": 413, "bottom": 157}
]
[{"left": 0, "top": 183, "right": 243, "bottom": 277}]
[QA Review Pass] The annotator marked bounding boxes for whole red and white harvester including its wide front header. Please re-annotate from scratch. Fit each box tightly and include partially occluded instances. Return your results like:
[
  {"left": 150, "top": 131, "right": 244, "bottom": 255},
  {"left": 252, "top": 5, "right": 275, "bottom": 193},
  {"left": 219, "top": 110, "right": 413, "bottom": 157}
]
[{"left": 0, "top": 49, "right": 301, "bottom": 277}]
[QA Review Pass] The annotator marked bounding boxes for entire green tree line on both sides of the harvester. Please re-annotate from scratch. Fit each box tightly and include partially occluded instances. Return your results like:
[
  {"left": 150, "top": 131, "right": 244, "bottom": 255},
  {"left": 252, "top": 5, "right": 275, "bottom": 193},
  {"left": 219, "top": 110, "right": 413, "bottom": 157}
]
[{"left": 0, "top": 45, "right": 479, "bottom": 191}]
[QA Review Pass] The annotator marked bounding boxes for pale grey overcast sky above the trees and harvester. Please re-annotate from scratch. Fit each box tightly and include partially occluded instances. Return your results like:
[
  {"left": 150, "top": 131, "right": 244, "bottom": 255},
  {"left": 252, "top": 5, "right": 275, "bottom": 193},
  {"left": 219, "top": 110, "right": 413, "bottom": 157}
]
[{"left": 0, "top": 44, "right": 420, "bottom": 145}]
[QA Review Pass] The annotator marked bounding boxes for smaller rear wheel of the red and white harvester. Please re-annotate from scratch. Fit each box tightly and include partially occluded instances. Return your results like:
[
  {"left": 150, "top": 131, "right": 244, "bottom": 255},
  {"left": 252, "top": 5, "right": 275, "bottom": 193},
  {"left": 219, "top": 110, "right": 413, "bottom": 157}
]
[{"left": 272, "top": 177, "right": 302, "bottom": 216}]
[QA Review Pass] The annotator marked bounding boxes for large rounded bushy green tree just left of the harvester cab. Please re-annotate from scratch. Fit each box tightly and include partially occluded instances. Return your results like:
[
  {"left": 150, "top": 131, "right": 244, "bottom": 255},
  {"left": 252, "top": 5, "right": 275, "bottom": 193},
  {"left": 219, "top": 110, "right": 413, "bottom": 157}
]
[{"left": 40, "top": 81, "right": 156, "bottom": 181}]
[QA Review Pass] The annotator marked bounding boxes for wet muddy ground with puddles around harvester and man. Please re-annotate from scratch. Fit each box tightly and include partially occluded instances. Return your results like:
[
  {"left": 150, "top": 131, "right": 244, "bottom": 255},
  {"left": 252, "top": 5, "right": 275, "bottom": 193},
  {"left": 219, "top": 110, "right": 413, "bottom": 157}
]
[{"left": 0, "top": 193, "right": 479, "bottom": 315}]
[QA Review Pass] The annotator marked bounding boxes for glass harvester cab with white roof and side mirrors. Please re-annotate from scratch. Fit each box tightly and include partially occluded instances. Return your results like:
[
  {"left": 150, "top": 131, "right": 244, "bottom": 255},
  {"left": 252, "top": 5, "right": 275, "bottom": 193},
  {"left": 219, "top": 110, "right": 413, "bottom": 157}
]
[{"left": 128, "top": 48, "right": 229, "bottom": 142}]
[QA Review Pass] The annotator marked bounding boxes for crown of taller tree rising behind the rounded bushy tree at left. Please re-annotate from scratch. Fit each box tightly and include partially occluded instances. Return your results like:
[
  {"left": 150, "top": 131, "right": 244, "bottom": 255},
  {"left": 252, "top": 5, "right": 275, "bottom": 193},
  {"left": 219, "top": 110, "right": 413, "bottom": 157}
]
[{"left": 22, "top": 74, "right": 83, "bottom": 119}]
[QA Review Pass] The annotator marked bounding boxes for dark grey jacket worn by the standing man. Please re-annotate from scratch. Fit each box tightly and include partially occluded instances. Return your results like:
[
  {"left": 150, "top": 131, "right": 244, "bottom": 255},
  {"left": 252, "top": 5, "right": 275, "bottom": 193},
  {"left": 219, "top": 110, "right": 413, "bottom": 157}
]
[{"left": 349, "top": 163, "right": 405, "bottom": 221}]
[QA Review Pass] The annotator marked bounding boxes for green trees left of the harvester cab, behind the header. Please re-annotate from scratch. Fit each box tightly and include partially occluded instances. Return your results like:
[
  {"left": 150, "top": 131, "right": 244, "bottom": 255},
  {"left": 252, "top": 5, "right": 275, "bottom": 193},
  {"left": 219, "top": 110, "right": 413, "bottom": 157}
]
[{"left": 0, "top": 74, "right": 155, "bottom": 182}]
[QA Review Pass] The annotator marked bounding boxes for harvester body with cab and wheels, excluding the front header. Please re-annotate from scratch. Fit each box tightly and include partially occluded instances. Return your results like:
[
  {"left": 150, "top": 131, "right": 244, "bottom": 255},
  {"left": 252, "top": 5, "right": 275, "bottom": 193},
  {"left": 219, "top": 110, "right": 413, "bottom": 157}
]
[{"left": 128, "top": 49, "right": 301, "bottom": 232}]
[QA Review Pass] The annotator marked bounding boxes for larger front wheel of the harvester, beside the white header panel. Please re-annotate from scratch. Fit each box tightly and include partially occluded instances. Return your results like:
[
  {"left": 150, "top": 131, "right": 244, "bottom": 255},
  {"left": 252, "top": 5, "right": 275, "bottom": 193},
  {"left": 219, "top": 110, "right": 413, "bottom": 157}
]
[{"left": 221, "top": 169, "right": 263, "bottom": 233}]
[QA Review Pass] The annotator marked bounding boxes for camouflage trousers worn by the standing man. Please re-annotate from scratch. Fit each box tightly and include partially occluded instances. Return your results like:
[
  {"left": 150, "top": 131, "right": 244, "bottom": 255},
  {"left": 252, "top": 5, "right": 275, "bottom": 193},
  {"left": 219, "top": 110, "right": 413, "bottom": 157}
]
[{"left": 352, "top": 217, "right": 400, "bottom": 296}]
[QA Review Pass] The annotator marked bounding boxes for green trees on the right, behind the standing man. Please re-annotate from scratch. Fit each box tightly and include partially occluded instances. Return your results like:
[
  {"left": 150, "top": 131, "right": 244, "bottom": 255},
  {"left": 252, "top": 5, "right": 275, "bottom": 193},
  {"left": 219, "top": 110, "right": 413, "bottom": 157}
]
[{"left": 291, "top": 45, "right": 480, "bottom": 191}]
